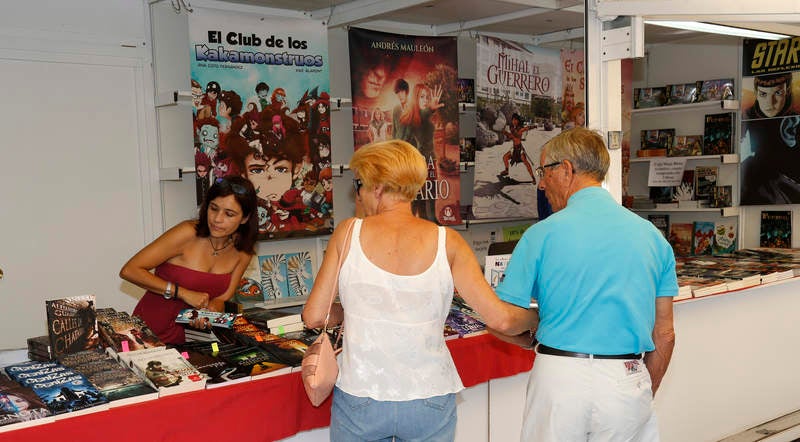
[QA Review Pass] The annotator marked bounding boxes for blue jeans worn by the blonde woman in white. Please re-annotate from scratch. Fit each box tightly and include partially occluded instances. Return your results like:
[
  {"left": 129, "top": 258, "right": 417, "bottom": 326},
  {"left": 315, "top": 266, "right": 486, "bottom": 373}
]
[{"left": 330, "top": 387, "right": 456, "bottom": 442}]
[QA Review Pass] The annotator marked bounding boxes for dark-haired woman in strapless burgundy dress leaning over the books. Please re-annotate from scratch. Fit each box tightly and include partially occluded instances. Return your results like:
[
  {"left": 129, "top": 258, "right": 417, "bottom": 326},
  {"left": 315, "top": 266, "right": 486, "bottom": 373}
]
[{"left": 119, "top": 176, "right": 258, "bottom": 344}]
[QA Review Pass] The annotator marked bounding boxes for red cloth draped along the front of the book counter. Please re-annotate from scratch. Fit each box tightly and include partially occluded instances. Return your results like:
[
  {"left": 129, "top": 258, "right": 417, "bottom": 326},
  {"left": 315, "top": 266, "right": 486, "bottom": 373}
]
[{"left": 0, "top": 335, "right": 534, "bottom": 442}]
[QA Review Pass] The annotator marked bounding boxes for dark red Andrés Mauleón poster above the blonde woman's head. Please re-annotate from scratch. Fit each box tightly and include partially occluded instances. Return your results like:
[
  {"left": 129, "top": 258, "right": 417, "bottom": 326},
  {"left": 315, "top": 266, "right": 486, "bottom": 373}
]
[{"left": 348, "top": 28, "right": 461, "bottom": 225}]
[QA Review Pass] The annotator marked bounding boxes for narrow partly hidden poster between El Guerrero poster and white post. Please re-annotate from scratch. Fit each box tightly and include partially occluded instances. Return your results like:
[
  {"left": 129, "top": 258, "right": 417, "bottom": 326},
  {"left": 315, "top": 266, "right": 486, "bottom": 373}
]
[{"left": 561, "top": 49, "right": 586, "bottom": 129}]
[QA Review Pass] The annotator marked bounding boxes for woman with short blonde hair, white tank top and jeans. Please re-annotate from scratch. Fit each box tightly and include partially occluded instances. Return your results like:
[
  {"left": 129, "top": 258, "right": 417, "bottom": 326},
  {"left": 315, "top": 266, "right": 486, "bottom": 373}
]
[{"left": 303, "top": 140, "right": 538, "bottom": 442}]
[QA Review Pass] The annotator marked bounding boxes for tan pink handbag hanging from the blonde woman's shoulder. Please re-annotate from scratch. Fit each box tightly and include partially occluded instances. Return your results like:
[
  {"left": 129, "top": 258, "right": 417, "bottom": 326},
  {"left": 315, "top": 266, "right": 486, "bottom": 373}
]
[{"left": 300, "top": 222, "right": 353, "bottom": 407}]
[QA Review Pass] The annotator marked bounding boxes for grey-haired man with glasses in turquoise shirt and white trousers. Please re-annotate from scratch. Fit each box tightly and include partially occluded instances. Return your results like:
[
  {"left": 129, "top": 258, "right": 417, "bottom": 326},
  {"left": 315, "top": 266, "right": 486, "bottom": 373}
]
[{"left": 497, "top": 128, "right": 678, "bottom": 441}]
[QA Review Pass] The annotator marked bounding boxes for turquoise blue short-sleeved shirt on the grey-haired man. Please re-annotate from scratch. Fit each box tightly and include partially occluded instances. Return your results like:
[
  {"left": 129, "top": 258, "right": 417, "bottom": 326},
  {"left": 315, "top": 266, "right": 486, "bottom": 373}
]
[{"left": 497, "top": 187, "right": 678, "bottom": 354}]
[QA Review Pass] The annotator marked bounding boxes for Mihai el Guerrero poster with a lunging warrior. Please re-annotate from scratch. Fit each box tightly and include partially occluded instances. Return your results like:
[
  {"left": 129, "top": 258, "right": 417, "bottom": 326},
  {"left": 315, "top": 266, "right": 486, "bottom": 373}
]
[{"left": 472, "top": 35, "right": 563, "bottom": 219}]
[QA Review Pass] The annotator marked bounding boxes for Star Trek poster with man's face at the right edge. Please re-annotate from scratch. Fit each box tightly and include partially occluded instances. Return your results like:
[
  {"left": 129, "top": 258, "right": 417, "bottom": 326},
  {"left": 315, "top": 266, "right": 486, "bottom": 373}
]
[{"left": 739, "top": 37, "right": 800, "bottom": 205}]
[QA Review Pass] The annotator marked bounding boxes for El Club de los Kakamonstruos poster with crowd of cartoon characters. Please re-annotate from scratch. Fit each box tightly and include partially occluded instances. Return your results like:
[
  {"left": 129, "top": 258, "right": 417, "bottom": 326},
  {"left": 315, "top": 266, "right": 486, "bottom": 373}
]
[{"left": 189, "top": 8, "right": 333, "bottom": 239}]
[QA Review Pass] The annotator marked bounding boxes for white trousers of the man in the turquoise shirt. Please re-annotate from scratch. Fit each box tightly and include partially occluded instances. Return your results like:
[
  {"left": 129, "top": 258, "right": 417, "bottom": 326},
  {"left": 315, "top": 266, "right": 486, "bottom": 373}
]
[{"left": 522, "top": 354, "right": 659, "bottom": 442}]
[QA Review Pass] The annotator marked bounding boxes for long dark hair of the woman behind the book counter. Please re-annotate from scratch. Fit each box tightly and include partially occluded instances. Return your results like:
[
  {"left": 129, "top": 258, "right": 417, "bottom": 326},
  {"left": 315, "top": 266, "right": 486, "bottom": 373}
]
[{"left": 195, "top": 176, "right": 258, "bottom": 255}]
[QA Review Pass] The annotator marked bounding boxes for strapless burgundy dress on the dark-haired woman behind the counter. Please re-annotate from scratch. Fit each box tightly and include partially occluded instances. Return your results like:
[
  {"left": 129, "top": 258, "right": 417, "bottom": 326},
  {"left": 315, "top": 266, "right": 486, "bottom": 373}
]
[{"left": 133, "top": 262, "right": 231, "bottom": 344}]
